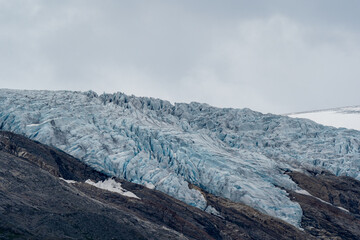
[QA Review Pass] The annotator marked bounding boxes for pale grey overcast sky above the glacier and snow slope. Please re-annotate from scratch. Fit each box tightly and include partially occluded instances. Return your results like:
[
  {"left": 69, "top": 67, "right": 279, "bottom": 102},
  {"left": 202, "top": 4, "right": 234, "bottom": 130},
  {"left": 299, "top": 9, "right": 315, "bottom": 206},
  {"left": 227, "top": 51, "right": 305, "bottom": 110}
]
[{"left": 0, "top": 0, "right": 360, "bottom": 113}]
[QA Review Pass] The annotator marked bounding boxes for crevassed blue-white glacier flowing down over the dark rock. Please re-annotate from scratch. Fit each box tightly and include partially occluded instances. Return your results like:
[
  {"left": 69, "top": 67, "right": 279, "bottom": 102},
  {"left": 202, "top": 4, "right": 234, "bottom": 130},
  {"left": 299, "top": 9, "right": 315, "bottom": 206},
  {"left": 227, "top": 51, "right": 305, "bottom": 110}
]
[{"left": 0, "top": 89, "right": 360, "bottom": 227}]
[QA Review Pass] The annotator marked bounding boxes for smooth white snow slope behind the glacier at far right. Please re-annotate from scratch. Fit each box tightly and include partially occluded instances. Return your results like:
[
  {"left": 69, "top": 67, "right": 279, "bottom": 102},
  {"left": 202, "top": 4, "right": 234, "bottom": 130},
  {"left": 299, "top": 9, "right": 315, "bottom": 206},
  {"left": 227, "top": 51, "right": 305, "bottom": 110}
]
[{"left": 288, "top": 106, "right": 360, "bottom": 130}]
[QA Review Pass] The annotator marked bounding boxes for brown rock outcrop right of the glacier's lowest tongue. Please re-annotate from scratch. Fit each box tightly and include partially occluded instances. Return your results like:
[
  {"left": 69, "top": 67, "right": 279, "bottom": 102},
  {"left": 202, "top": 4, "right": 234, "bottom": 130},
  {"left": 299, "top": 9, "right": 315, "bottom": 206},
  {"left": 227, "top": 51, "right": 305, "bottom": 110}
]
[{"left": 288, "top": 172, "right": 360, "bottom": 239}]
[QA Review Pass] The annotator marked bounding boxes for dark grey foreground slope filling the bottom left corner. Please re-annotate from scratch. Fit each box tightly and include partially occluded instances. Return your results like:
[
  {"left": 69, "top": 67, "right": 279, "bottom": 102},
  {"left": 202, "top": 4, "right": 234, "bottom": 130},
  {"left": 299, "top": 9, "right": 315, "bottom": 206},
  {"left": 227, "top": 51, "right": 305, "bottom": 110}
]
[{"left": 0, "top": 136, "right": 180, "bottom": 239}]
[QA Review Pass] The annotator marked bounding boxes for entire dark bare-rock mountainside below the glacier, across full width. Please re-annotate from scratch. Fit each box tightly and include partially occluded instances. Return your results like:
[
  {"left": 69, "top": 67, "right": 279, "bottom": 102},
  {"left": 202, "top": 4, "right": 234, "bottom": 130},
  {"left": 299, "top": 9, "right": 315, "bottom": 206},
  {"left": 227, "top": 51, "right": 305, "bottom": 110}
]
[{"left": 0, "top": 132, "right": 360, "bottom": 239}]
